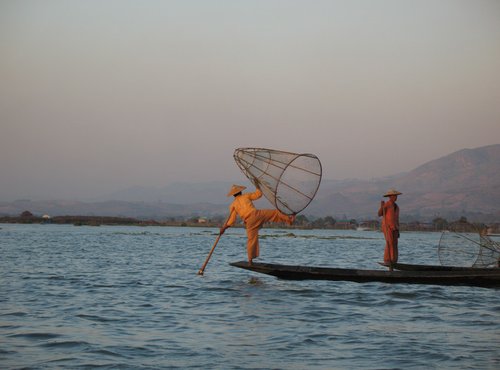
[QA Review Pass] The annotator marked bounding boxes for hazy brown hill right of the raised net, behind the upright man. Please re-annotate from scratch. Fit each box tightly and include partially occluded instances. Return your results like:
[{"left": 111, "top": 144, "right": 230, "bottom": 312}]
[{"left": 307, "top": 144, "right": 500, "bottom": 220}]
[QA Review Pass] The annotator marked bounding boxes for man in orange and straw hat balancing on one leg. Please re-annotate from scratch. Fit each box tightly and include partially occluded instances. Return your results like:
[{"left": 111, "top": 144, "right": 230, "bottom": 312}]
[{"left": 220, "top": 184, "right": 295, "bottom": 264}]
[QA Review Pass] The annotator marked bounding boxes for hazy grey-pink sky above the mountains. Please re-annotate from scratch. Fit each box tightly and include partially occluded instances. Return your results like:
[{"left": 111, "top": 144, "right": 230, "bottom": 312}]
[{"left": 0, "top": 0, "right": 500, "bottom": 201}]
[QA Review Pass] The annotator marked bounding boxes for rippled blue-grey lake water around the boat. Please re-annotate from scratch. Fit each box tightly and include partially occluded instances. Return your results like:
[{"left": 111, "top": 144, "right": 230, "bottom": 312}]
[{"left": 0, "top": 224, "right": 500, "bottom": 369}]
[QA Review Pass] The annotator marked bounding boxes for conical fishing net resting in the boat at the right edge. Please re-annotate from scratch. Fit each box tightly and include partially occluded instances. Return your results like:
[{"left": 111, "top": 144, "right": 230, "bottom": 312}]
[{"left": 438, "top": 224, "right": 500, "bottom": 268}]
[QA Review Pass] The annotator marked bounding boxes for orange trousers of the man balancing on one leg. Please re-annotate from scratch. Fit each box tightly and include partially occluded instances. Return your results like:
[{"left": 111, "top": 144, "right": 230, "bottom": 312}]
[{"left": 245, "top": 209, "right": 289, "bottom": 261}]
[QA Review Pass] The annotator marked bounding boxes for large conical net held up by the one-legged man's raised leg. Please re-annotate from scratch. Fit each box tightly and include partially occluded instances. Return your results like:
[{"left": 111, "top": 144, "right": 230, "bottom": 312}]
[{"left": 234, "top": 148, "right": 322, "bottom": 215}]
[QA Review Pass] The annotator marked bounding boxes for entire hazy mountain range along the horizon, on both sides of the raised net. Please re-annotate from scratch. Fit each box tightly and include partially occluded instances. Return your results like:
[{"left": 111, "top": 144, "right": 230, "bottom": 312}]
[{"left": 0, "top": 144, "right": 500, "bottom": 222}]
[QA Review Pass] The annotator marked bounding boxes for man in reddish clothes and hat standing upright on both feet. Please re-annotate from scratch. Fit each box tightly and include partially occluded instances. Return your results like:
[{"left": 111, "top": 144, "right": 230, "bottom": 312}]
[{"left": 378, "top": 189, "right": 402, "bottom": 271}]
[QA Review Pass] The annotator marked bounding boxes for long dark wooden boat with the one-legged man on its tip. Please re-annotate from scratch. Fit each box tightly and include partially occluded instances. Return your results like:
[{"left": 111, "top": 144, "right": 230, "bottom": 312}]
[{"left": 231, "top": 261, "right": 500, "bottom": 287}]
